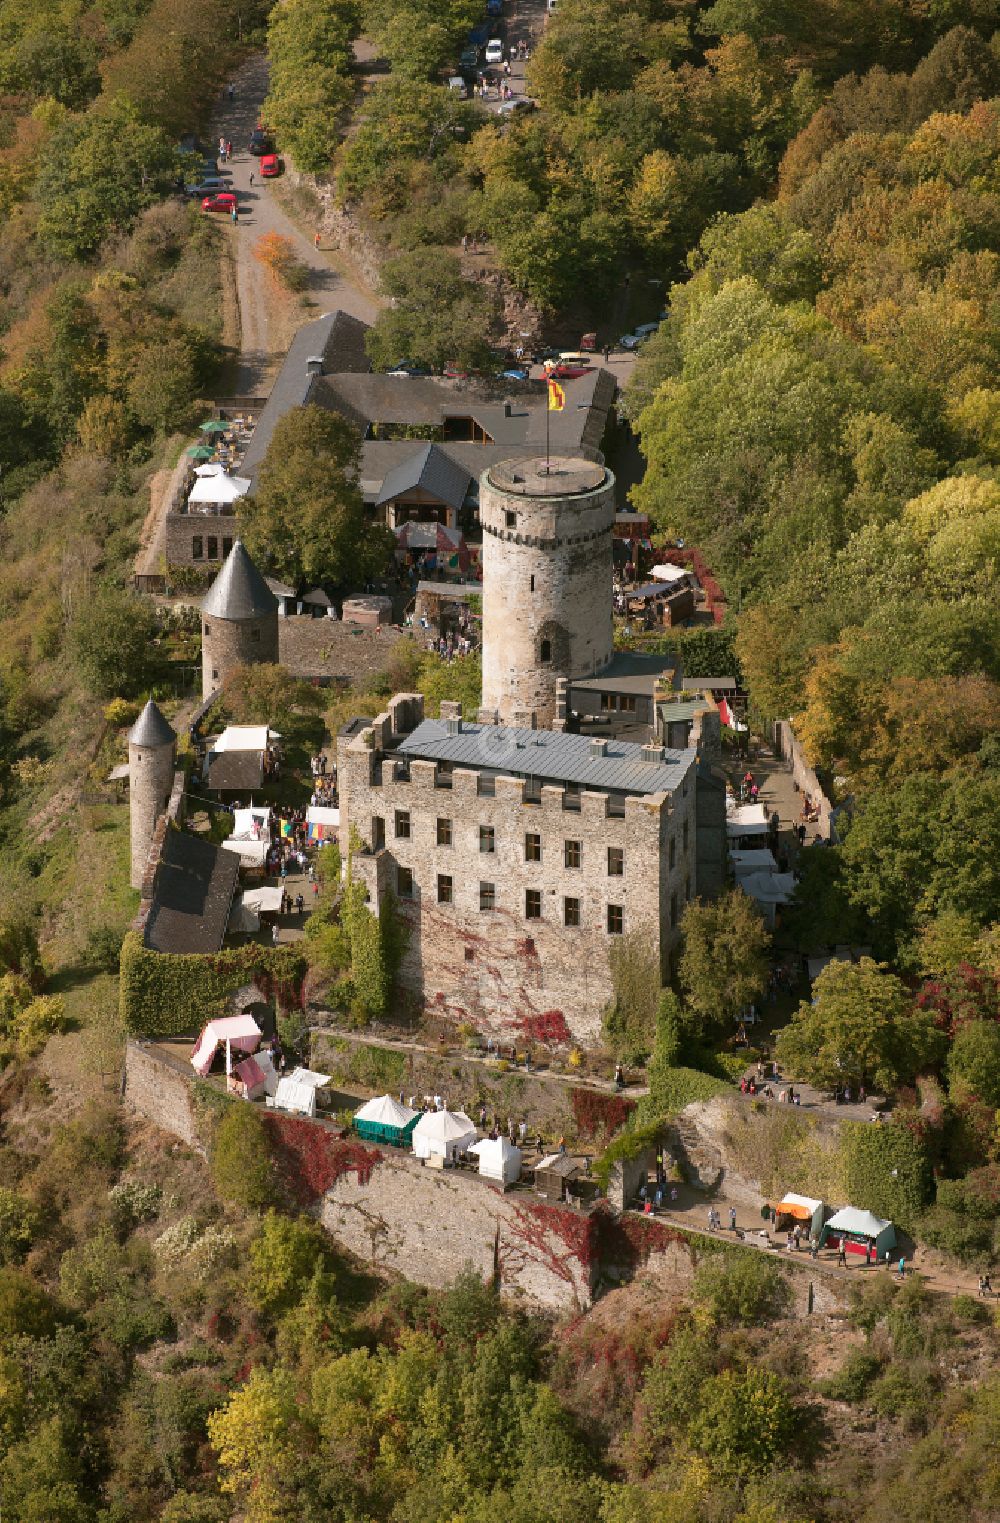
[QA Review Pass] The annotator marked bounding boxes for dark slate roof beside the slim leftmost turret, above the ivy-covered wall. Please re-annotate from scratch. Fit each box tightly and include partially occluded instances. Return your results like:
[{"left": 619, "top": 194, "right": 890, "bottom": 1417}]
[{"left": 143, "top": 830, "right": 239, "bottom": 952}]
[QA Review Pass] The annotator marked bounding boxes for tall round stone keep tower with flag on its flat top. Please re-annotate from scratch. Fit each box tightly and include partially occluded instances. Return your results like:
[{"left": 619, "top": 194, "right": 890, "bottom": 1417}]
[{"left": 479, "top": 457, "right": 615, "bottom": 730}]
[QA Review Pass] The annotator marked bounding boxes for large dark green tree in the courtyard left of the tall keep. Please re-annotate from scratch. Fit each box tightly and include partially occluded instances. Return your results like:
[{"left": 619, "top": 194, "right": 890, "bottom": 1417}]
[{"left": 237, "top": 407, "right": 393, "bottom": 586}]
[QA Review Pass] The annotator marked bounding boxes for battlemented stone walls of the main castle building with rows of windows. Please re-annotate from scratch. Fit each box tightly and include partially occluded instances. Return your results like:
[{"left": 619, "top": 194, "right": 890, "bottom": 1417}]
[{"left": 341, "top": 720, "right": 696, "bottom": 1043}]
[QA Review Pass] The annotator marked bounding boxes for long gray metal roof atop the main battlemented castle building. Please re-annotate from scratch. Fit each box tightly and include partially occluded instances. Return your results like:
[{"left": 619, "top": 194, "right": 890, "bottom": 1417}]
[{"left": 399, "top": 719, "right": 694, "bottom": 793}]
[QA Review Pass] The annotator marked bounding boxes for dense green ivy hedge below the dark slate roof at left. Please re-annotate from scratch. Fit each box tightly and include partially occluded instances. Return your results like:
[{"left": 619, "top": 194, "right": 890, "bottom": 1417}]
[{"left": 119, "top": 931, "right": 307, "bottom": 1037}]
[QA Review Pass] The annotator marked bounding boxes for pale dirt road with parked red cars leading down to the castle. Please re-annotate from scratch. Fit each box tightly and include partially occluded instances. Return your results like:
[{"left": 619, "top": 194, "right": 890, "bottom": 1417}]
[{"left": 209, "top": 56, "right": 377, "bottom": 396}]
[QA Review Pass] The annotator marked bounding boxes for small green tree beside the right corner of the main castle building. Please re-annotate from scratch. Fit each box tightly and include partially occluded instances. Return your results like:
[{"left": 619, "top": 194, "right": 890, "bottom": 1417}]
[{"left": 677, "top": 888, "right": 770, "bottom": 1034}]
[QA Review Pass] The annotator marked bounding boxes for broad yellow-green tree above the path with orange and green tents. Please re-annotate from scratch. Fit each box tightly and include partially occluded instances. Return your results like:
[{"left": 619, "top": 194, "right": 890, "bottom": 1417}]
[{"left": 776, "top": 956, "right": 944, "bottom": 1090}]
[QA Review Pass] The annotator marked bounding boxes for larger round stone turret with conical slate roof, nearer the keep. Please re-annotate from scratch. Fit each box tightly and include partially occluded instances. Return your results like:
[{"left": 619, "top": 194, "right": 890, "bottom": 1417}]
[{"left": 201, "top": 539, "right": 279, "bottom": 698}]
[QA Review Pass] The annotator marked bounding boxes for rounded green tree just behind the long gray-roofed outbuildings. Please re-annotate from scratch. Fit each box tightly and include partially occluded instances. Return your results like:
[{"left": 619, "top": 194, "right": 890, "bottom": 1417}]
[{"left": 367, "top": 248, "right": 496, "bottom": 370}]
